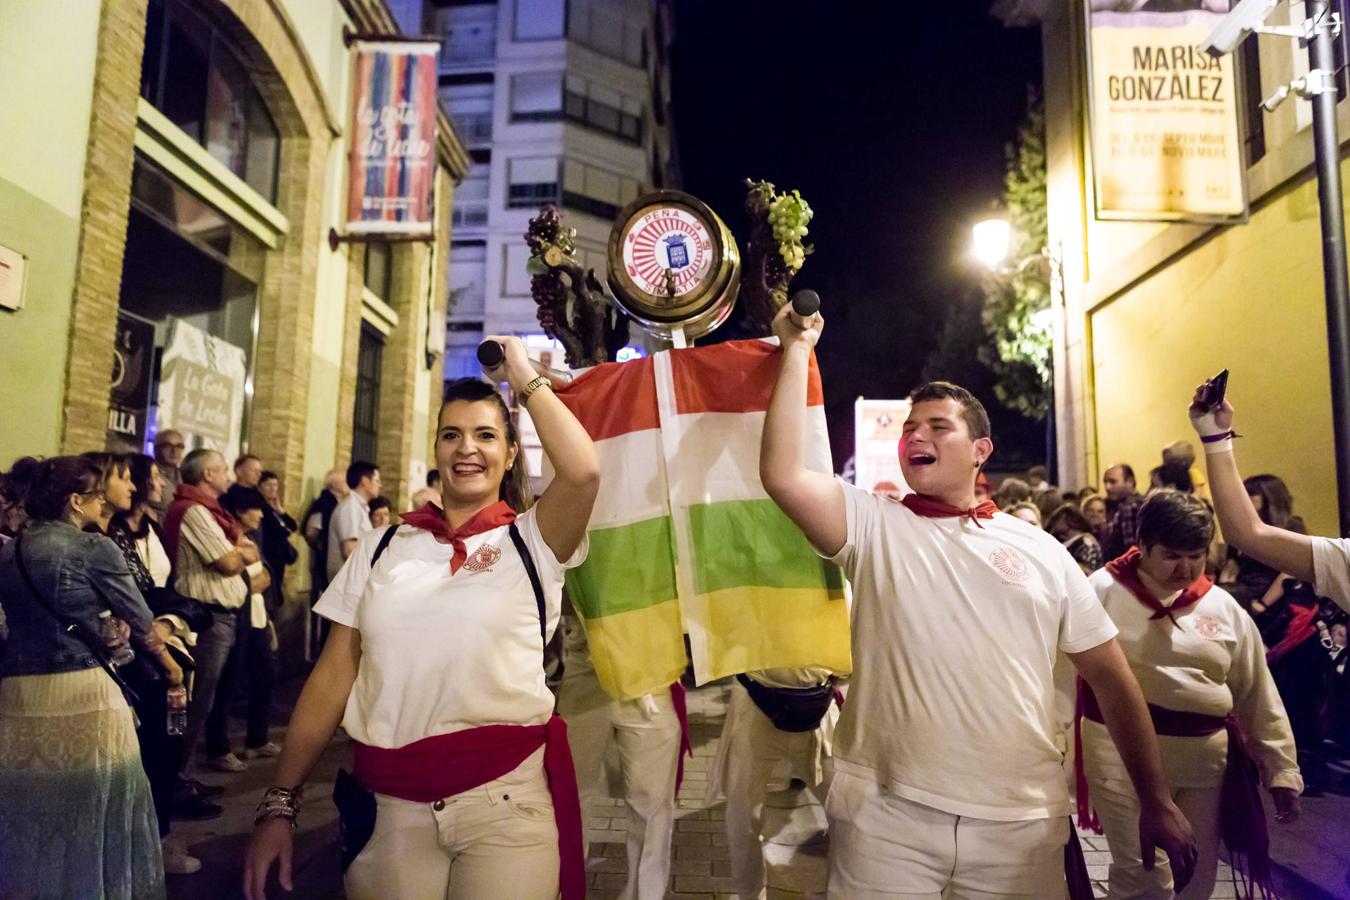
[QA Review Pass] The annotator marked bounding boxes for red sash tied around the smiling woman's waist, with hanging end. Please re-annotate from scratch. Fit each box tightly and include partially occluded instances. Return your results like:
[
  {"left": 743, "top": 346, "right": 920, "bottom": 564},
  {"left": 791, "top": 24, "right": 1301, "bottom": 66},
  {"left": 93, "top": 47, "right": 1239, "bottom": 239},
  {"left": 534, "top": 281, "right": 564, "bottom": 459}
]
[{"left": 352, "top": 715, "right": 586, "bottom": 900}]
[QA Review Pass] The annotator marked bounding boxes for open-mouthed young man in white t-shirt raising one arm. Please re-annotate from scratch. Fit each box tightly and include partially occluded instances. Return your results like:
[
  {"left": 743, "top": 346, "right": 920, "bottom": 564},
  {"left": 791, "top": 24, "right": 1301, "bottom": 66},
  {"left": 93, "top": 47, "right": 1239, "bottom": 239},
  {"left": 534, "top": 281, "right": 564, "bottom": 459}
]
[{"left": 760, "top": 306, "right": 1196, "bottom": 899}]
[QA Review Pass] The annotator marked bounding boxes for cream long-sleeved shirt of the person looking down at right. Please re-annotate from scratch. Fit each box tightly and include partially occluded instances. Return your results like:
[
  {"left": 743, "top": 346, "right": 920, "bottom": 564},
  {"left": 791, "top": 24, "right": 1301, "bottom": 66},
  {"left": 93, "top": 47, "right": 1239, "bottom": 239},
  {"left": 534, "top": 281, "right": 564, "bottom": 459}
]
[{"left": 1083, "top": 569, "right": 1303, "bottom": 791}]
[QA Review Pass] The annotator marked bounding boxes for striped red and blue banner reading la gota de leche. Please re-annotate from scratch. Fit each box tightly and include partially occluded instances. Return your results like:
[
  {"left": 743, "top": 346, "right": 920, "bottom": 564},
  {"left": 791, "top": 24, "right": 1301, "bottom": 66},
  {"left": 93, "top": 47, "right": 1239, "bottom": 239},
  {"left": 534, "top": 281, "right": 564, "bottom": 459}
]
[{"left": 347, "top": 42, "right": 440, "bottom": 235}]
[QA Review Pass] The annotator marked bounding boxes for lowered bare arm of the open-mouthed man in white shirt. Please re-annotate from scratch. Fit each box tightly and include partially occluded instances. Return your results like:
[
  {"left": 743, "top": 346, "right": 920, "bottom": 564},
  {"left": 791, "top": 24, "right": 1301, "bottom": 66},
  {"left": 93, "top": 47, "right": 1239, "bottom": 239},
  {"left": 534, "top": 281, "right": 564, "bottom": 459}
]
[{"left": 1068, "top": 638, "right": 1196, "bottom": 891}]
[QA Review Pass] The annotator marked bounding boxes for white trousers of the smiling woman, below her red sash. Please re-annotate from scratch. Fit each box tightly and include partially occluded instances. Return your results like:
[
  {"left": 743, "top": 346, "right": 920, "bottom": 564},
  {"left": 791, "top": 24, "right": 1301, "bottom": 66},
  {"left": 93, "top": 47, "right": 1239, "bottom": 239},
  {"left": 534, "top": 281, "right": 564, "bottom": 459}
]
[{"left": 343, "top": 749, "right": 559, "bottom": 900}]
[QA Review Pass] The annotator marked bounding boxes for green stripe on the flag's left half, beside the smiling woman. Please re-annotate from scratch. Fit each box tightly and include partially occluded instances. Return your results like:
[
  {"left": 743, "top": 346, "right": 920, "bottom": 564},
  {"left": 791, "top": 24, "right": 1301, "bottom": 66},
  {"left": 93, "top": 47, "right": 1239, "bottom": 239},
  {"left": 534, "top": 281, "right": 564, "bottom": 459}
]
[{"left": 567, "top": 515, "right": 675, "bottom": 619}]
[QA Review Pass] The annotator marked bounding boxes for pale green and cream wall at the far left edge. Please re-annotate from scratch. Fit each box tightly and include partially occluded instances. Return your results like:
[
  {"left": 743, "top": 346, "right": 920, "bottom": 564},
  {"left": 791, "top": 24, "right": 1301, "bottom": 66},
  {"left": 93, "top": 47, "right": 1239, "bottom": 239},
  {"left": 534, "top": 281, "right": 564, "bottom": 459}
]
[{"left": 0, "top": 0, "right": 99, "bottom": 468}]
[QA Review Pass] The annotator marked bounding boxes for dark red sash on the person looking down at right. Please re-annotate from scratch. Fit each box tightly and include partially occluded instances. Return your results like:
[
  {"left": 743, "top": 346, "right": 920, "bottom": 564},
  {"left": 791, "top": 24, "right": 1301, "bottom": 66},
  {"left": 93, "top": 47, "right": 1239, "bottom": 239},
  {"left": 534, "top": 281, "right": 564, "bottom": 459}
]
[{"left": 1073, "top": 679, "right": 1272, "bottom": 896}]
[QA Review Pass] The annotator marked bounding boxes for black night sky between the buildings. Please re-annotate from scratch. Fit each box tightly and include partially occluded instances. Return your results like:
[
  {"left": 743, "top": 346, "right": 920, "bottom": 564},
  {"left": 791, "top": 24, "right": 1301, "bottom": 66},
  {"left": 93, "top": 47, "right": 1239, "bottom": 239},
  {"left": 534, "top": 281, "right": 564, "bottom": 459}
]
[{"left": 671, "top": 0, "right": 1041, "bottom": 467}]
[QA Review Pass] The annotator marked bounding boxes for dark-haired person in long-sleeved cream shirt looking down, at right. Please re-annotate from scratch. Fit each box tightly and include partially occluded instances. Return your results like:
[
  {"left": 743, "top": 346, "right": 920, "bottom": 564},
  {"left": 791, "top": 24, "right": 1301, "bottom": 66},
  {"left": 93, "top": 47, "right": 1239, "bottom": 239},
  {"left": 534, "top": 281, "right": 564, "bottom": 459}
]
[{"left": 1077, "top": 490, "right": 1303, "bottom": 900}]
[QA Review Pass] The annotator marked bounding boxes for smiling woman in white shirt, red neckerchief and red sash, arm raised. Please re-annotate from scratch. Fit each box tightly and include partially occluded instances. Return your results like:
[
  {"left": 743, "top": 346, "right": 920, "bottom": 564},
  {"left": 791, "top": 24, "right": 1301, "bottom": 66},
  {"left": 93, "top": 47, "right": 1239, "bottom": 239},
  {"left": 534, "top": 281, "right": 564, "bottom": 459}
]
[{"left": 244, "top": 337, "right": 599, "bottom": 900}]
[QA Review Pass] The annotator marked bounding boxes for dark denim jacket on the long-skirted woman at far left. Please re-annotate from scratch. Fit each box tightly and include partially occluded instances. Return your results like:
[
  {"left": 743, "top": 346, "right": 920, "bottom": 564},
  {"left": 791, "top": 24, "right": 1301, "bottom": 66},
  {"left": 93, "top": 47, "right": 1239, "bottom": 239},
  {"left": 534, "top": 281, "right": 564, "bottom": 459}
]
[{"left": 0, "top": 522, "right": 159, "bottom": 677}]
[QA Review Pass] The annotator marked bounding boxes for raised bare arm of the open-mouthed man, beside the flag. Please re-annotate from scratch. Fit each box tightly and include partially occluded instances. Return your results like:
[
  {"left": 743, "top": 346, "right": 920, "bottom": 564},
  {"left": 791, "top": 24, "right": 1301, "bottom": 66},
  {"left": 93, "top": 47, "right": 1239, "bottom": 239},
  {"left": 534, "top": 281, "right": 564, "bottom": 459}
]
[{"left": 760, "top": 304, "right": 848, "bottom": 556}]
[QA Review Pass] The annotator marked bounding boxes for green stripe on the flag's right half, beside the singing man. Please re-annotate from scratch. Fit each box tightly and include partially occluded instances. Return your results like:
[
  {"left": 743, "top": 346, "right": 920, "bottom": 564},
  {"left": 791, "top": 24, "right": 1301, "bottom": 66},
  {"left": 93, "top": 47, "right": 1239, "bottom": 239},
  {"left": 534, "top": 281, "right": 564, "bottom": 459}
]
[{"left": 685, "top": 499, "right": 844, "bottom": 594}]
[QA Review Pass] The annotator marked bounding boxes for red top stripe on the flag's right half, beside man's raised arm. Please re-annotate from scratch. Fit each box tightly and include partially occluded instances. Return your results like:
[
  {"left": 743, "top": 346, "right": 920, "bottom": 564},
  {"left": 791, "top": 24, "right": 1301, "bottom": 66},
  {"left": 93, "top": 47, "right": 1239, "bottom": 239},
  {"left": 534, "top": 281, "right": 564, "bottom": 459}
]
[{"left": 671, "top": 340, "right": 825, "bottom": 414}]
